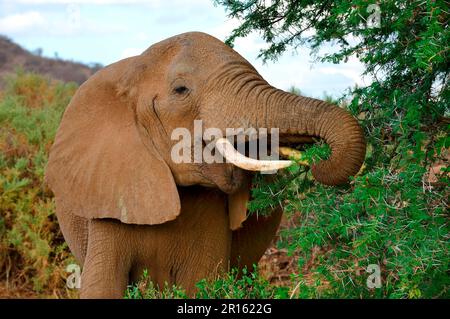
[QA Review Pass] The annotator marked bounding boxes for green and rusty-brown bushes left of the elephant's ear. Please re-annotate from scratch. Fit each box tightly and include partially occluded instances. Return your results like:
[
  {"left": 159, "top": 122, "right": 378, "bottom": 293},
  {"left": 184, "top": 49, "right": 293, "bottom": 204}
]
[{"left": 0, "top": 70, "right": 76, "bottom": 296}]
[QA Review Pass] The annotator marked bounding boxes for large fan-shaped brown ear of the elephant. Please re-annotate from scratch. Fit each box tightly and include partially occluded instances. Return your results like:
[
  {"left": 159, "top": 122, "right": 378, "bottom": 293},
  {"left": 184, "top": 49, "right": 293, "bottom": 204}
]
[{"left": 46, "top": 58, "right": 180, "bottom": 225}]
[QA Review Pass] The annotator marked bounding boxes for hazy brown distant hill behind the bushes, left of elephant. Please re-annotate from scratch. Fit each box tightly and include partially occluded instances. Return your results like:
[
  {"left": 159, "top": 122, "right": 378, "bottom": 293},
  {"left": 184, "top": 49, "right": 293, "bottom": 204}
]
[{"left": 0, "top": 35, "right": 101, "bottom": 84}]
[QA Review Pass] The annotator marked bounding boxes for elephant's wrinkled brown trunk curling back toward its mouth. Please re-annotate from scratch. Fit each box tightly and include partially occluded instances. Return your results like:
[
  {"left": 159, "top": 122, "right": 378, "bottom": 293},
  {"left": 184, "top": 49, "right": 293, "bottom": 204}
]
[{"left": 261, "top": 88, "right": 366, "bottom": 185}]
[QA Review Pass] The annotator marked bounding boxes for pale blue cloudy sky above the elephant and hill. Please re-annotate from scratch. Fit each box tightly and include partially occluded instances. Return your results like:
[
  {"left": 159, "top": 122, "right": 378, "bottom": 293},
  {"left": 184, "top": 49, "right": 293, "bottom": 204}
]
[{"left": 0, "top": 0, "right": 367, "bottom": 97}]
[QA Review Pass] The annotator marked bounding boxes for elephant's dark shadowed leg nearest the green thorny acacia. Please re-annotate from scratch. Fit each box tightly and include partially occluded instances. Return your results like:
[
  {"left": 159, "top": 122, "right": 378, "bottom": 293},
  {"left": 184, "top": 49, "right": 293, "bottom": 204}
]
[{"left": 230, "top": 207, "right": 283, "bottom": 270}]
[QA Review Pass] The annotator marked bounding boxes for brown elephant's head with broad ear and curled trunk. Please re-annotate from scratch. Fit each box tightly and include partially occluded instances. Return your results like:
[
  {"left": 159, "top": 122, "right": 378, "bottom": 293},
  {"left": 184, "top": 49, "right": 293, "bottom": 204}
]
[{"left": 46, "top": 32, "right": 365, "bottom": 229}]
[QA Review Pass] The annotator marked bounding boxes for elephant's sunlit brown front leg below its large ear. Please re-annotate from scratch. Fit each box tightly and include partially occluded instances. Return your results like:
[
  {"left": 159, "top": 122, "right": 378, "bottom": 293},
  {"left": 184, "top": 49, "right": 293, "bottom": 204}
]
[{"left": 80, "top": 219, "right": 131, "bottom": 298}]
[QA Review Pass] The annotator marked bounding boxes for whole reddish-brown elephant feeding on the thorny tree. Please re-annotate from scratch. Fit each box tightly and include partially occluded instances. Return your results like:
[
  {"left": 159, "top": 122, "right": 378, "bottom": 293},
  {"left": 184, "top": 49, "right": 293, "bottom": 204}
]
[{"left": 45, "top": 32, "right": 366, "bottom": 298}]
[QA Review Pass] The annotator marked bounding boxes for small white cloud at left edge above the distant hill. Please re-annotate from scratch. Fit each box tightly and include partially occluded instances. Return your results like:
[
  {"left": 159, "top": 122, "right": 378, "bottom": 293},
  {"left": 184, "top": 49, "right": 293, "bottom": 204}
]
[{"left": 0, "top": 11, "right": 46, "bottom": 33}]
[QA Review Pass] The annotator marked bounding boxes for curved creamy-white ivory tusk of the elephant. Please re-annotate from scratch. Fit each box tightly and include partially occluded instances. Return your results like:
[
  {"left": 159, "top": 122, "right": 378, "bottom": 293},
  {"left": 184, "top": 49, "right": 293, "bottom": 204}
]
[{"left": 215, "top": 138, "right": 293, "bottom": 172}]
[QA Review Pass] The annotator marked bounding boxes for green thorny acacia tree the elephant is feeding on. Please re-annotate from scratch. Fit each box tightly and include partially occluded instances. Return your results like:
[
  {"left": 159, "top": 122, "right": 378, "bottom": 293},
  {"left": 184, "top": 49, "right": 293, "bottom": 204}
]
[{"left": 215, "top": 0, "right": 450, "bottom": 298}]
